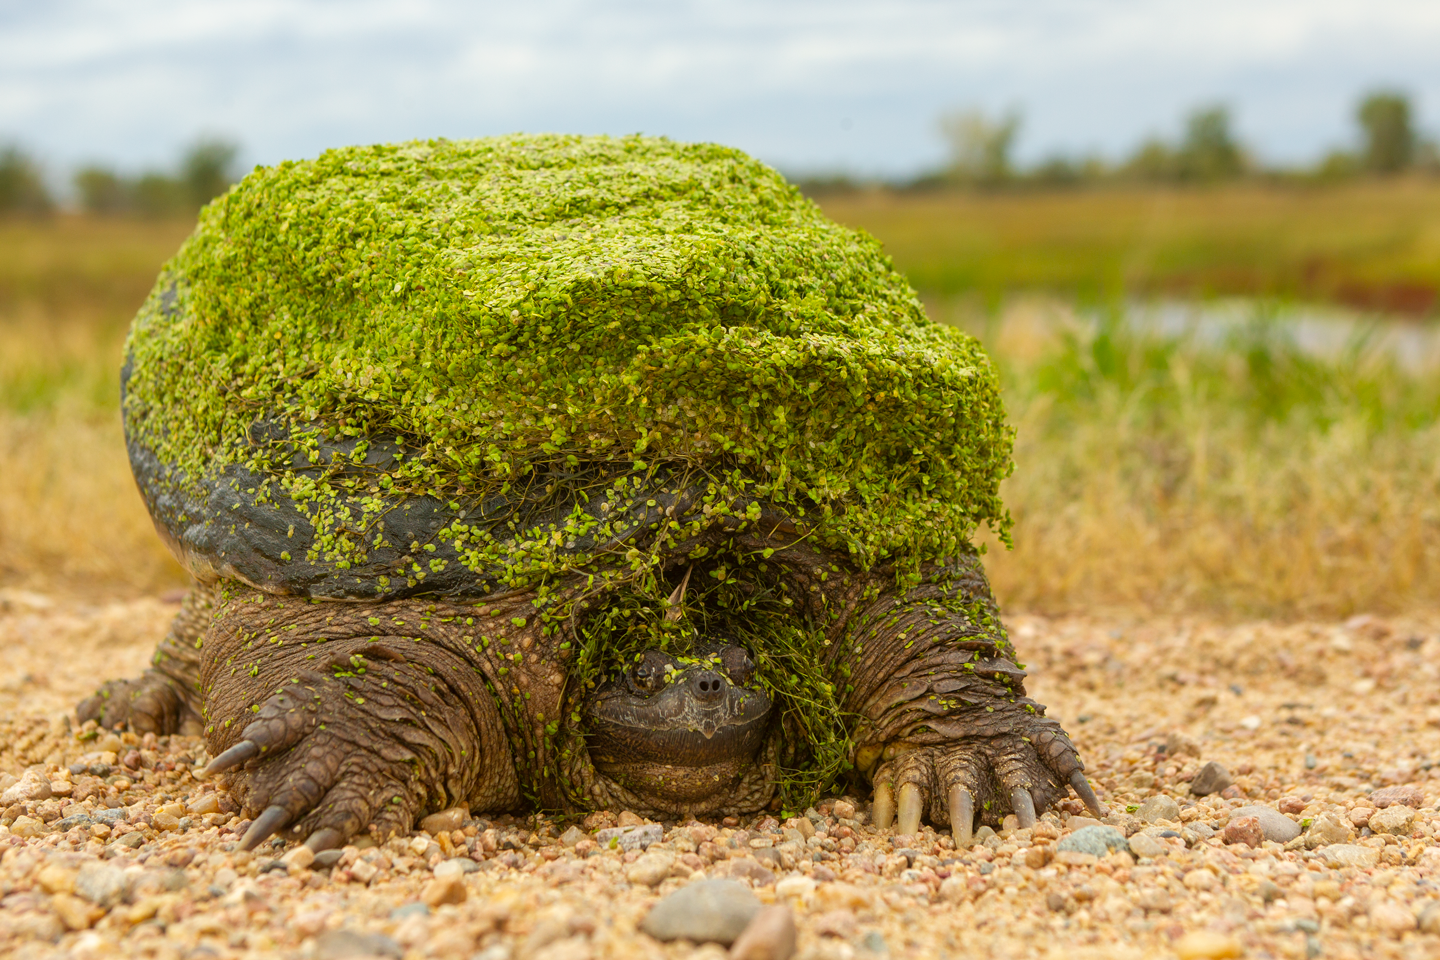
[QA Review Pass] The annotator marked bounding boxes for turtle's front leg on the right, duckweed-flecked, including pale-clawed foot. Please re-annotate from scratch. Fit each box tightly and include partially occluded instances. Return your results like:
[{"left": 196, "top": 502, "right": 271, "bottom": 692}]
[{"left": 840, "top": 556, "right": 1104, "bottom": 845}]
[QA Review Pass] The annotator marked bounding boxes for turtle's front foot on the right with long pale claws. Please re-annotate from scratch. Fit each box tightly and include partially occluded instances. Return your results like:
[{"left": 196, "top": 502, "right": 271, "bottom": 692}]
[{"left": 861, "top": 711, "right": 1106, "bottom": 848}]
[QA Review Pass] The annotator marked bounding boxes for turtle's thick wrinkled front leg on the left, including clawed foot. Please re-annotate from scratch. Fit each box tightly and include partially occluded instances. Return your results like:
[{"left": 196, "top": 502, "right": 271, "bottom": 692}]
[{"left": 202, "top": 584, "right": 528, "bottom": 851}]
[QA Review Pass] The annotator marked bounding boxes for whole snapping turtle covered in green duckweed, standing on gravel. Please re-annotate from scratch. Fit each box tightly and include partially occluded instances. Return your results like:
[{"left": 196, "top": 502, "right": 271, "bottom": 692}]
[{"left": 79, "top": 137, "right": 1100, "bottom": 849}]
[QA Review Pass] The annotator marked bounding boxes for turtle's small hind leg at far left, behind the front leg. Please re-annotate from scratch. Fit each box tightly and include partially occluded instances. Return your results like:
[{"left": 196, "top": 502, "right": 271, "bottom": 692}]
[{"left": 75, "top": 584, "right": 215, "bottom": 735}]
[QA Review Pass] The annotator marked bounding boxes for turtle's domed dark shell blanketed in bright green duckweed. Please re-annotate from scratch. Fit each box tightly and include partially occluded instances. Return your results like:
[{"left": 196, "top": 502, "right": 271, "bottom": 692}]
[{"left": 122, "top": 135, "right": 1012, "bottom": 597}]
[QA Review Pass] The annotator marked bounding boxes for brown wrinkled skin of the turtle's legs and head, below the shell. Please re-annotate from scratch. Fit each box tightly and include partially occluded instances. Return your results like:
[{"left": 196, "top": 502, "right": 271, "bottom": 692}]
[{"left": 79, "top": 503, "right": 1100, "bottom": 849}]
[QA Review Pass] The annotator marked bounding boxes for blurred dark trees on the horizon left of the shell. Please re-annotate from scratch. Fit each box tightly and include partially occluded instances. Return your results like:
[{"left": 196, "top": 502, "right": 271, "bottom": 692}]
[{"left": 0, "top": 138, "right": 239, "bottom": 217}]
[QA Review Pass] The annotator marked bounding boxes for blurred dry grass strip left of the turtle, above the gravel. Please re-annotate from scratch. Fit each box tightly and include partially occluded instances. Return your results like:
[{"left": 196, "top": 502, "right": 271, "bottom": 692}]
[{"left": 0, "top": 219, "right": 190, "bottom": 593}]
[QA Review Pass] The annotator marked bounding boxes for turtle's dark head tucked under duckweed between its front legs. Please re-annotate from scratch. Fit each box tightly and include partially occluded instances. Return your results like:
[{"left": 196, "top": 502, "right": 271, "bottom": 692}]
[{"left": 585, "top": 643, "right": 772, "bottom": 806}]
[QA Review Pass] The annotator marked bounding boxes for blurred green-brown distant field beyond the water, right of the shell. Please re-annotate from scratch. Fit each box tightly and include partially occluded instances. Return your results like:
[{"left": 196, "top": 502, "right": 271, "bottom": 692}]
[{"left": 818, "top": 178, "right": 1440, "bottom": 315}]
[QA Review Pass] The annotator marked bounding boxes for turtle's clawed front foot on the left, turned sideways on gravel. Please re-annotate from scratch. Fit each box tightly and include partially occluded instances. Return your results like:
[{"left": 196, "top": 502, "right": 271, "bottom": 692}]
[{"left": 202, "top": 642, "right": 509, "bottom": 851}]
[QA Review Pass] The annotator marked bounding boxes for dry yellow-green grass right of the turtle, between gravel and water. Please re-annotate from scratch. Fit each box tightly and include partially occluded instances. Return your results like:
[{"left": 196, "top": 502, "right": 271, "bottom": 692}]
[{"left": 967, "top": 297, "right": 1440, "bottom": 616}]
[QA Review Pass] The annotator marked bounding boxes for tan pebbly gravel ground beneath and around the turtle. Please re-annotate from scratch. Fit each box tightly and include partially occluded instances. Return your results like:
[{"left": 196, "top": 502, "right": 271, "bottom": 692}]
[{"left": 0, "top": 592, "right": 1440, "bottom": 960}]
